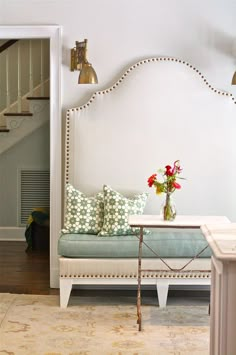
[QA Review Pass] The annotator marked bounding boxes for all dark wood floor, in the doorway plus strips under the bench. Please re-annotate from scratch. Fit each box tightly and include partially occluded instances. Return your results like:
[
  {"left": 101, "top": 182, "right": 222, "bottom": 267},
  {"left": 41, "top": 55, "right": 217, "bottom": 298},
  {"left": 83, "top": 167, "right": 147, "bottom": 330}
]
[{"left": 0, "top": 241, "right": 210, "bottom": 302}]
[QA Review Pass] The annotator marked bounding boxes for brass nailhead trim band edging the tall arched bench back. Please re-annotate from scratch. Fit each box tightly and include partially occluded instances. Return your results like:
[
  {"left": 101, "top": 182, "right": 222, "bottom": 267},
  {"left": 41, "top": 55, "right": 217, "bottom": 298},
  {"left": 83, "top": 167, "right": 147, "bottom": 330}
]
[{"left": 65, "top": 57, "right": 236, "bottom": 183}]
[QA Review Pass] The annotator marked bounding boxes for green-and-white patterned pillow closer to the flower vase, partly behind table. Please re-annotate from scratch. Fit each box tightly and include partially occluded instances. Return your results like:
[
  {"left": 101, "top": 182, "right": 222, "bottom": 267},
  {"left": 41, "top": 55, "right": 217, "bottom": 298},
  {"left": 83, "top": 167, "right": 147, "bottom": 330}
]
[{"left": 99, "top": 185, "right": 148, "bottom": 236}]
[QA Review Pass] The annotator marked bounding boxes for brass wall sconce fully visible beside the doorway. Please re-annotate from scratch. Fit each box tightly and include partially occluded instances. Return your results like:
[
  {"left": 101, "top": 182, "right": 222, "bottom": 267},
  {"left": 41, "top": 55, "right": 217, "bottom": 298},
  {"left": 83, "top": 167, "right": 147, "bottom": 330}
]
[{"left": 70, "top": 39, "right": 98, "bottom": 84}]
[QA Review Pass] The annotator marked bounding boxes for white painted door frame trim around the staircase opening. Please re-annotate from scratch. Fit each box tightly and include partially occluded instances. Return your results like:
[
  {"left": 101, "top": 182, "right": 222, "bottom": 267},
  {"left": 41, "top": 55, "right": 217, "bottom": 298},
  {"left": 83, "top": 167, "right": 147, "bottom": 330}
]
[{"left": 0, "top": 25, "right": 62, "bottom": 288}]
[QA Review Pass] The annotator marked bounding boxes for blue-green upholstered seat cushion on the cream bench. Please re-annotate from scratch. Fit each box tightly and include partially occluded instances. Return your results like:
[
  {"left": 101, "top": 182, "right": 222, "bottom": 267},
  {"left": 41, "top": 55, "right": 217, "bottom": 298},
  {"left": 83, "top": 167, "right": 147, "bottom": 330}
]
[{"left": 58, "top": 229, "right": 211, "bottom": 258}]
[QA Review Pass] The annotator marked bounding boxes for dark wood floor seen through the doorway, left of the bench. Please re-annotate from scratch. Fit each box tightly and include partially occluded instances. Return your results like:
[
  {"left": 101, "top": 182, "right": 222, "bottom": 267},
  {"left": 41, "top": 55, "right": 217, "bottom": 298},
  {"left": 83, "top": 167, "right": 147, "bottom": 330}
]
[{"left": 0, "top": 241, "right": 58, "bottom": 295}]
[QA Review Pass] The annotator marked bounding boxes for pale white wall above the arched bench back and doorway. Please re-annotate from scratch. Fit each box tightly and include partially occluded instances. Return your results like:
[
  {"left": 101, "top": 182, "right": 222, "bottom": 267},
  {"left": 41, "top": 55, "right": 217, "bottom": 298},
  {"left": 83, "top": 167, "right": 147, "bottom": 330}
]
[{"left": 0, "top": 0, "right": 236, "bottom": 112}]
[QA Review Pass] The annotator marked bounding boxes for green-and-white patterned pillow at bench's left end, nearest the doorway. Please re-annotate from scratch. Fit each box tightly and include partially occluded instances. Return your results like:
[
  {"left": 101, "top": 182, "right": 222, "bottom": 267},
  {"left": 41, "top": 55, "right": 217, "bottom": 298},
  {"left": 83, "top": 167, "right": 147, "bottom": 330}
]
[{"left": 62, "top": 184, "right": 104, "bottom": 234}]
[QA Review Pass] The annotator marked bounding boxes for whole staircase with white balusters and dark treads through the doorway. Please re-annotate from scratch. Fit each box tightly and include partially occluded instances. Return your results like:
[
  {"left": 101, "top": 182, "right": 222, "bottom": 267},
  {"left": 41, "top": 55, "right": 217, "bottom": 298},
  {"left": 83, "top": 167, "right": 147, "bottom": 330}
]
[{"left": 0, "top": 39, "right": 50, "bottom": 154}]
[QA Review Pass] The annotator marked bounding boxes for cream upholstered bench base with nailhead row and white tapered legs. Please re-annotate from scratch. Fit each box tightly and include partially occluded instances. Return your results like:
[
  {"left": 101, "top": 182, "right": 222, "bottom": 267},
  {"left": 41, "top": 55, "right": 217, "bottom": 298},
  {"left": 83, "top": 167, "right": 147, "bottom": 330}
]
[{"left": 60, "top": 257, "right": 211, "bottom": 308}]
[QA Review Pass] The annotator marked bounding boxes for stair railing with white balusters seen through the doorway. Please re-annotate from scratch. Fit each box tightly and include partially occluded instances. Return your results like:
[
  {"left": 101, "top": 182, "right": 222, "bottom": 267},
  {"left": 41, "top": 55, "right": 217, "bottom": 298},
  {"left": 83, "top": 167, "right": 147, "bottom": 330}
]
[{"left": 0, "top": 39, "right": 49, "bottom": 129}]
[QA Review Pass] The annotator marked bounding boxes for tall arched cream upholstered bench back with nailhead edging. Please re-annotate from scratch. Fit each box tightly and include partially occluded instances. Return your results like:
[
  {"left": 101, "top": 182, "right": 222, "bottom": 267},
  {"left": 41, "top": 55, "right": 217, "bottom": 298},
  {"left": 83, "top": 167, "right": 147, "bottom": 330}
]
[{"left": 65, "top": 57, "right": 236, "bottom": 221}]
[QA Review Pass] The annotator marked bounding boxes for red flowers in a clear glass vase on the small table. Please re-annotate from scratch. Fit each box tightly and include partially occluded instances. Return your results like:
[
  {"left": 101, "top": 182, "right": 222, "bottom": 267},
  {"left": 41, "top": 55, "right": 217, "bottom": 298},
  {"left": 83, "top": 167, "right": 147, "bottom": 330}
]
[{"left": 147, "top": 160, "right": 183, "bottom": 221}]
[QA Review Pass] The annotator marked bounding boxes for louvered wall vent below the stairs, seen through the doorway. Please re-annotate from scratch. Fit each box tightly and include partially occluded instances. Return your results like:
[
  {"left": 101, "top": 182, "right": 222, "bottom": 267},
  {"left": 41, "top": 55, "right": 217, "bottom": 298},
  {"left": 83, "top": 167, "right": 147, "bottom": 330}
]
[{"left": 19, "top": 169, "right": 50, "bottom": 225}]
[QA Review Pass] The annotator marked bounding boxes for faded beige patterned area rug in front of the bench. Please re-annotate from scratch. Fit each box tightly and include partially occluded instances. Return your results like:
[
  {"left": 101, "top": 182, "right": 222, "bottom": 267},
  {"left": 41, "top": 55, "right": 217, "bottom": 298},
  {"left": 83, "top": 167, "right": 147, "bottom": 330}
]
[{"left": 0, "top": 294, "right": 209, "bottom": 355}]
